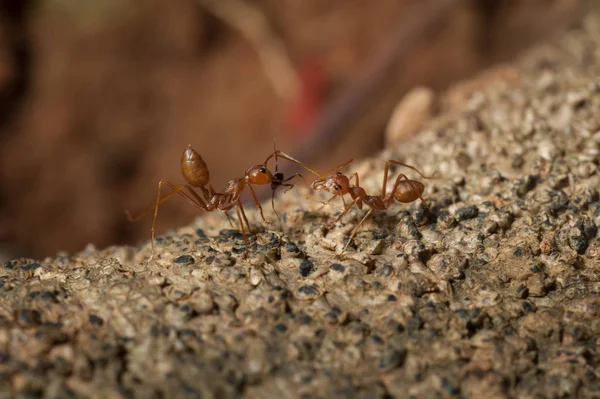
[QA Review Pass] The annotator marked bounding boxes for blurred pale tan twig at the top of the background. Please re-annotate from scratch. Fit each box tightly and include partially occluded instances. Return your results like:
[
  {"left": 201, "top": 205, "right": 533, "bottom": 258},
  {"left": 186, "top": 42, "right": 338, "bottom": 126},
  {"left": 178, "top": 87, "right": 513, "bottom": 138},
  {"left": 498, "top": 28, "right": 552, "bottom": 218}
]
[{"left": 198, "top": 0, "right": 300, "bottom": 101}]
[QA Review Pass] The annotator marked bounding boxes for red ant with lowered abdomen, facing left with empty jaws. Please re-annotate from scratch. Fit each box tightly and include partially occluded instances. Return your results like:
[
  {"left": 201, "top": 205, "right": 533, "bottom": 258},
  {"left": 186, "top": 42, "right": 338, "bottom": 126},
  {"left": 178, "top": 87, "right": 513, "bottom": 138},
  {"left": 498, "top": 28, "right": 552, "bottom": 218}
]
[{"left": 311, "top": 159, "right": 435, "bottom": 256}]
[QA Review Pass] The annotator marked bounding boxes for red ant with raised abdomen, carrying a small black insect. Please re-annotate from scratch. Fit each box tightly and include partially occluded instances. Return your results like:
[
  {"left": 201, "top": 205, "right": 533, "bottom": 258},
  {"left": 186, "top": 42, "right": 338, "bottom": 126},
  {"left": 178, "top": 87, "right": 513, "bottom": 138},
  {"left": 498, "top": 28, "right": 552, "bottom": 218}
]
[{"left": 126, "top": 145, "right": 318, "bottom": 259}]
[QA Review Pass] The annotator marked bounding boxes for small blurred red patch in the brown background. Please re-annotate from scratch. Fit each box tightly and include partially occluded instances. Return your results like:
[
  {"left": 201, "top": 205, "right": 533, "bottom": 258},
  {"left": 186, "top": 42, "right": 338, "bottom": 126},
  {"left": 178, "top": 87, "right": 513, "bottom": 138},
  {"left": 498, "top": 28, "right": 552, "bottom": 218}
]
[{"left": 285, "top": 60, "right": 326, "bottom": 138}]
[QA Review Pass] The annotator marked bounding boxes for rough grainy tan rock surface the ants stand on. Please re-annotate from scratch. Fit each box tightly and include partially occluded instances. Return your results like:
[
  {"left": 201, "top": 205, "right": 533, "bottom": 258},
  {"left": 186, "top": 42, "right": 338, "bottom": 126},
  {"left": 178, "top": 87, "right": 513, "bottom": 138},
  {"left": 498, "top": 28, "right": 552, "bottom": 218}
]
[{"left": 0, "top": 16, "right": 600, "bottom": 398}]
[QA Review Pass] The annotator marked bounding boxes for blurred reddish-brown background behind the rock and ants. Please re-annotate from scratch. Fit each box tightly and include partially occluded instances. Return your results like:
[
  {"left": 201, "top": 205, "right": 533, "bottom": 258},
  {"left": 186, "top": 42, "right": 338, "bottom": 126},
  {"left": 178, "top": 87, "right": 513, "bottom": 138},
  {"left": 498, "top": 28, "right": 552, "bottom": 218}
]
[{"left": 0, "top": 0, "right": 596, "bottom": 257}]
